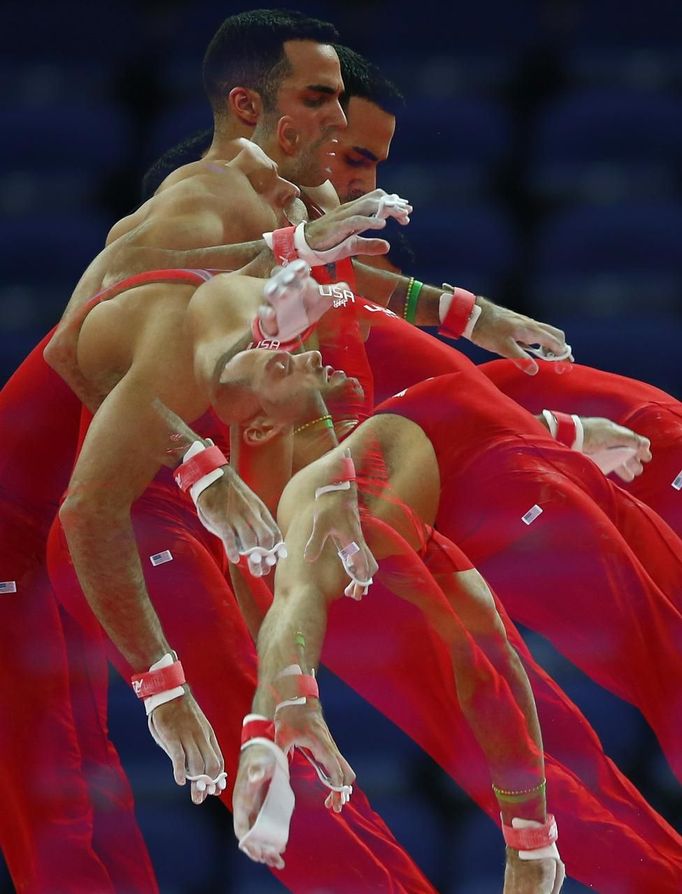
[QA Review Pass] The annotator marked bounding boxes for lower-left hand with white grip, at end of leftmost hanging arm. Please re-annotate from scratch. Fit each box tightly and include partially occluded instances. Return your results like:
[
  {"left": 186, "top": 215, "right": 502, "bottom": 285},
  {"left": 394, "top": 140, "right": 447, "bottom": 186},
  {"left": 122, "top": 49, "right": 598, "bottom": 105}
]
[{"left": 149, "top": 690, "right": 225, "bottom": 804}]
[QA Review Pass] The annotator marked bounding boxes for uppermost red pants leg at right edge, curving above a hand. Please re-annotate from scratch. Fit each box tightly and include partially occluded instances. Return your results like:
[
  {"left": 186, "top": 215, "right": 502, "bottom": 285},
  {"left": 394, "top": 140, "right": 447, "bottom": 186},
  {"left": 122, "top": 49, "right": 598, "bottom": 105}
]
[{"left": 479, "top": 360, "right": 682, "bottom": 535}]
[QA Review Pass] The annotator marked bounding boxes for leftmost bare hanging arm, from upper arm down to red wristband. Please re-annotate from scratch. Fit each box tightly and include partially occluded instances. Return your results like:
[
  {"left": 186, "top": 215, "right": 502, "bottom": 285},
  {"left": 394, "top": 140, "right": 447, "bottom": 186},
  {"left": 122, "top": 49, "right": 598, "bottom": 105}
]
[{"left": 60, "top": 376, "right": 181, "bottom": 671}]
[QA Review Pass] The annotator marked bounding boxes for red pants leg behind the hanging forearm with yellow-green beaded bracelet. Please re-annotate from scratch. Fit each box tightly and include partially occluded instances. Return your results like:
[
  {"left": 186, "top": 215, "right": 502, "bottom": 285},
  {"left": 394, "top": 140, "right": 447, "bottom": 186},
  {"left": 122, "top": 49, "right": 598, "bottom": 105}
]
[{"left": 323, "top": 524, "right": 682, "bottom": 894}]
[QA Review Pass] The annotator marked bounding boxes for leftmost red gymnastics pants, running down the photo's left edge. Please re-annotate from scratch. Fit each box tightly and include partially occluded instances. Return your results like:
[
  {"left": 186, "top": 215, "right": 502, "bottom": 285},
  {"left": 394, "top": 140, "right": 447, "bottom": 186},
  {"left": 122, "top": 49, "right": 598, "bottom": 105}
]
[{"left": 0, "top": 336, "right": 157, "bottom": 894}]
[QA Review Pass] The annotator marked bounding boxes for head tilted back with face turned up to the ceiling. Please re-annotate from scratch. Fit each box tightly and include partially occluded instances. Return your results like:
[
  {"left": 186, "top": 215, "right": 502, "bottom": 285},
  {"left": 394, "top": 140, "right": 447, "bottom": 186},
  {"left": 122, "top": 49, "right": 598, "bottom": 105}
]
[{"left": 212, "top": 348, "right": 360, "bottom": 446}]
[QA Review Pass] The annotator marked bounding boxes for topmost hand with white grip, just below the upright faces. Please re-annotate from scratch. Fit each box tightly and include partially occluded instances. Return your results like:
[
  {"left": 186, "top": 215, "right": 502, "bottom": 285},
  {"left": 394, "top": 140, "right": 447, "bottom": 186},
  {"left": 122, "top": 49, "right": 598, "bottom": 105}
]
[{"left": 304, "top": 189, "right": 412, "bottom": 263}]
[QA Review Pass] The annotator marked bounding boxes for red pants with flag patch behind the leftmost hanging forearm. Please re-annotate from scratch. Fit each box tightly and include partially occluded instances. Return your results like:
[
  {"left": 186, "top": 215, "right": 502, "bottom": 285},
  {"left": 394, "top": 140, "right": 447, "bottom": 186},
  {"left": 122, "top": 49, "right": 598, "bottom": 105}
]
[{"left": 49, "top": 485, "right": 433, "bottom": 894}]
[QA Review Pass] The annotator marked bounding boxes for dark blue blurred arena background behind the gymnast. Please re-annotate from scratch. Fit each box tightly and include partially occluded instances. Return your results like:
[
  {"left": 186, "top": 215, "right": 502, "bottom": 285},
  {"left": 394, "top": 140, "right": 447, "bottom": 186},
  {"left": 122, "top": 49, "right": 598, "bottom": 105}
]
[{"left": 0, "top": 0, "right": 682, "bottom": 894}]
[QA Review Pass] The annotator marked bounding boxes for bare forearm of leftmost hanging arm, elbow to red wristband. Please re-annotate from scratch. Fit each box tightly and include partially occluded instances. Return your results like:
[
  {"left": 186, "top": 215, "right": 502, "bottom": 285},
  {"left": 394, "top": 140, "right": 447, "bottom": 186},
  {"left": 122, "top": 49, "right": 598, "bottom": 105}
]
[{"left": 60, "top": 497, "right": 170, "bottom": 671}]
